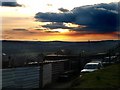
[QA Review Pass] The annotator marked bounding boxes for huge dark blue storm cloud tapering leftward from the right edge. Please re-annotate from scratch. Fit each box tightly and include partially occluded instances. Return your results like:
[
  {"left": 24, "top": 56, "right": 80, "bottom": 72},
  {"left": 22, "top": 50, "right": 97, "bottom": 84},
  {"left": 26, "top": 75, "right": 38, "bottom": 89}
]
[{"left": 35, "top": 3, "right": 119, "bottom": 33}]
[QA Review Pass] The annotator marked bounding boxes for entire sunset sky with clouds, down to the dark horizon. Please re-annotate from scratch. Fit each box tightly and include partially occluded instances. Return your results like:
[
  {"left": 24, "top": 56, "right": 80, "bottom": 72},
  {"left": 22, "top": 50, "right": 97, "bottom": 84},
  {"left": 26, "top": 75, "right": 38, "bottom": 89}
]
[{"left": 0, "top": 0, "right": 120, "bottom": 41}]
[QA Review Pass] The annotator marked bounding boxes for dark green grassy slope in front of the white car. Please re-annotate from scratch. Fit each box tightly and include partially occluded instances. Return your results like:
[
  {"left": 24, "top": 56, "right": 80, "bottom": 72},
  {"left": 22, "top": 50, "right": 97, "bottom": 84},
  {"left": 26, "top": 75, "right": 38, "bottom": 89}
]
[{"left": 71, "top": 64, "right": 120, "bottom": 88}]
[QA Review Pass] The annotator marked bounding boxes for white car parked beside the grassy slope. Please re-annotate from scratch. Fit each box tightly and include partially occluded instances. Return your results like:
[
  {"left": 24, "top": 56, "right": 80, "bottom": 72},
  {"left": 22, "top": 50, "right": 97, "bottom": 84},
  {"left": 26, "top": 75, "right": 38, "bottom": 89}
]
[{"left": 81, "top": 61, "right": 103, "bottom": 73}]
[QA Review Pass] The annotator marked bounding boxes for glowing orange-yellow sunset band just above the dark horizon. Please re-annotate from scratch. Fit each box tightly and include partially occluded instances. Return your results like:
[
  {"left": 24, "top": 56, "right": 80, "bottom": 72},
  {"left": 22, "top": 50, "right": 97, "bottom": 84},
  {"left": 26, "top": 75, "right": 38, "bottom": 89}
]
[{"left": 3, "top": 31, "right": 118, "bottom": 42}]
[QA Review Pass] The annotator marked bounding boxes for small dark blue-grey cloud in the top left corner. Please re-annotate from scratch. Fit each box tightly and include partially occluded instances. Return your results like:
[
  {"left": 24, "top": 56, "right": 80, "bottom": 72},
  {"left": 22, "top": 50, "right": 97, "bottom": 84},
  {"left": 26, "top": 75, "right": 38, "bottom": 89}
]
[{"left": 0, "top": 0, "right": 22, "bottom": 7}]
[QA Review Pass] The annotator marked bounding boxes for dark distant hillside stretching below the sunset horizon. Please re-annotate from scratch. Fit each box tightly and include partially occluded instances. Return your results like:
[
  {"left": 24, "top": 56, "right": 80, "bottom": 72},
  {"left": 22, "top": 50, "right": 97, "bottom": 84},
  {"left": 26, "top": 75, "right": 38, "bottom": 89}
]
[{"left": 2, "top": 40, "right": 120, "bottom": 62}]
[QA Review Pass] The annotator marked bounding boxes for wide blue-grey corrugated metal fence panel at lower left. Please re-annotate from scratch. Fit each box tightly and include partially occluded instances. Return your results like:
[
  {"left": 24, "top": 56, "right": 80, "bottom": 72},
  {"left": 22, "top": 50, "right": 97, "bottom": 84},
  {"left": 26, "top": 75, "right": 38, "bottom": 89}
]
[{"left": 2, "top": 67, "right": 39, "bottom": 88}]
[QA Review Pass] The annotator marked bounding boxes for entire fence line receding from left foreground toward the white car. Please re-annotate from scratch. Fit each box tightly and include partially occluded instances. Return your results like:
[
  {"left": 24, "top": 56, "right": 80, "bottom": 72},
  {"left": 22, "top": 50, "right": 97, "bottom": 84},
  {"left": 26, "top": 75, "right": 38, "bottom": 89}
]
[{"left": 2, "top": 59, "right": 79, "bottom": 88}]
